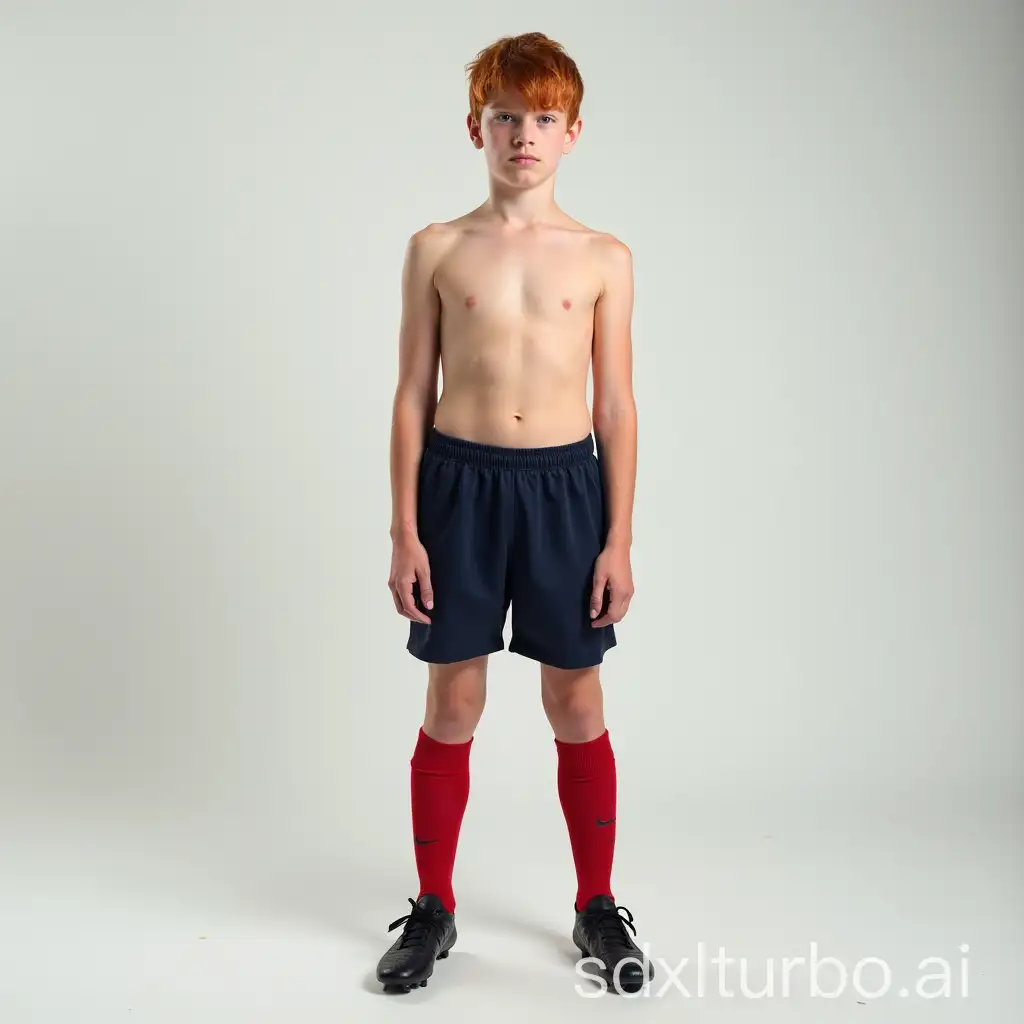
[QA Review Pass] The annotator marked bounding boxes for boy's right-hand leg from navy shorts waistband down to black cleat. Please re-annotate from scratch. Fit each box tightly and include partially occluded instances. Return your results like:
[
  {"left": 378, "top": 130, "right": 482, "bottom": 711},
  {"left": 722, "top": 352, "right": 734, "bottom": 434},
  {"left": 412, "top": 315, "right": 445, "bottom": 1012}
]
[{"left": 509, "top": 438, "right": 653, "bottom": 991}]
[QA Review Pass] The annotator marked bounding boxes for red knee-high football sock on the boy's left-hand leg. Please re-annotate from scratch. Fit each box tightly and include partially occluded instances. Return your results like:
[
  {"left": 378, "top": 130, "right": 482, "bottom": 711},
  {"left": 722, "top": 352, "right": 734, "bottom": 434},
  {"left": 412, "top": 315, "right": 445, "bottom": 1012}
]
[{"left": 410, "top": 728, "right": 473, "bottom": 913}]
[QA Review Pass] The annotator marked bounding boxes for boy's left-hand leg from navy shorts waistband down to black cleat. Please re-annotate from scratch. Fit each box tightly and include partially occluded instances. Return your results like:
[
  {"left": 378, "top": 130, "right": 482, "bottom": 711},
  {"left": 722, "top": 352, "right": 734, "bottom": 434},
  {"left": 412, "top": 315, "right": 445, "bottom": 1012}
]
[{"left": 377, "top": 431, "right": 510, "bottom": 989}]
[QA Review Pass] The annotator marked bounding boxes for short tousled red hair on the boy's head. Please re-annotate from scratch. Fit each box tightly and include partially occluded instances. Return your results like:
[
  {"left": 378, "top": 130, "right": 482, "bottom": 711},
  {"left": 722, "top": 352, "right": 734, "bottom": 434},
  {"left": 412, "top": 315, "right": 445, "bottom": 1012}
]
[{"left": 466, "top": 32, "right": 583, "bottom": 125}]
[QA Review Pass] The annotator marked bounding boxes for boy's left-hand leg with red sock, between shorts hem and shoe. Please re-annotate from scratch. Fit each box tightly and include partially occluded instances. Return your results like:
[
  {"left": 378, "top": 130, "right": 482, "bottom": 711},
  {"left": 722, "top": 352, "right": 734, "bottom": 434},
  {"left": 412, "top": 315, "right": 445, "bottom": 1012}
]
[{"left": 410, "top": 657, "right": 487, "bottom": 913}]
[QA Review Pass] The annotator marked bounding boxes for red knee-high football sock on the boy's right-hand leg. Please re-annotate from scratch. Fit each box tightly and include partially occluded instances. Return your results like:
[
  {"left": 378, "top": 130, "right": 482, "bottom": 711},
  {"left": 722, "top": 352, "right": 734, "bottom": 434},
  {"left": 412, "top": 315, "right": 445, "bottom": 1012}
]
[{"left": 555, "top": 730, "right": 615, "bottom": 910}]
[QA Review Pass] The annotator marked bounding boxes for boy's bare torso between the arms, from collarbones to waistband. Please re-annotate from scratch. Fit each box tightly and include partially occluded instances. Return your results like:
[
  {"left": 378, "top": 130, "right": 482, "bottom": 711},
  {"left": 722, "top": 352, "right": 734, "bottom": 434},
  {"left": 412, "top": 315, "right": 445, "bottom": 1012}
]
[{"left": 425, "top": 214, "right": 609, "bottom": 447}]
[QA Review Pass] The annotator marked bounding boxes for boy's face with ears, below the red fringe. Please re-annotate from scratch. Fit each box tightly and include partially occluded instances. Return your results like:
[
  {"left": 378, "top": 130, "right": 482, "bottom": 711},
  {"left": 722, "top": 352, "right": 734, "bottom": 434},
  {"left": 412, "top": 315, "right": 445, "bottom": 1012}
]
[{"left": 466, "top": 92, "right": 583, "bottom": 188}]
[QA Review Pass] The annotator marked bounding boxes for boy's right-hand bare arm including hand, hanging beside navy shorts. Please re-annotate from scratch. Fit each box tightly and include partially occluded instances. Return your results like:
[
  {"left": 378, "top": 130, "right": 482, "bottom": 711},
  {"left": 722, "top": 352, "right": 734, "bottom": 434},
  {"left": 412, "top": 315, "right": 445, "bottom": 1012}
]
[{"left": 591, "top": 239, "right": 637, "bottom": 627}]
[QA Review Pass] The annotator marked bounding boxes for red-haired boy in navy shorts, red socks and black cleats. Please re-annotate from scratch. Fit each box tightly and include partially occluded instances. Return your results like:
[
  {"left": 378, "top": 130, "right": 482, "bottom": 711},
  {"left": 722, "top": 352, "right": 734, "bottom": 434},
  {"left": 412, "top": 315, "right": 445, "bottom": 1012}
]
[{"left": 377, "top": 33, "right": 652, "bottom": 991}]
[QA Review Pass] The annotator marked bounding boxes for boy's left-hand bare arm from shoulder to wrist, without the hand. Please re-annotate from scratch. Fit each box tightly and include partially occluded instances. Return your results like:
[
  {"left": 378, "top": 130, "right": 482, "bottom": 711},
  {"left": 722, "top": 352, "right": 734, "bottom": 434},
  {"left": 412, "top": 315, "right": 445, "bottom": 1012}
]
[{"left": 391, "top": 227, "right": 440, "bottom": 541}]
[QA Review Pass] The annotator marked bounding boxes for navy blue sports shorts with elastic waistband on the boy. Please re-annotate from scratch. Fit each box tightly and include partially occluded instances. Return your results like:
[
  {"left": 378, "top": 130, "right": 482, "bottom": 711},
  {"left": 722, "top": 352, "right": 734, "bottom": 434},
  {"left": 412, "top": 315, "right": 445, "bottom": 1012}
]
[{"left": 408, "top": 430, "right": 615, "bottom": 669}]
